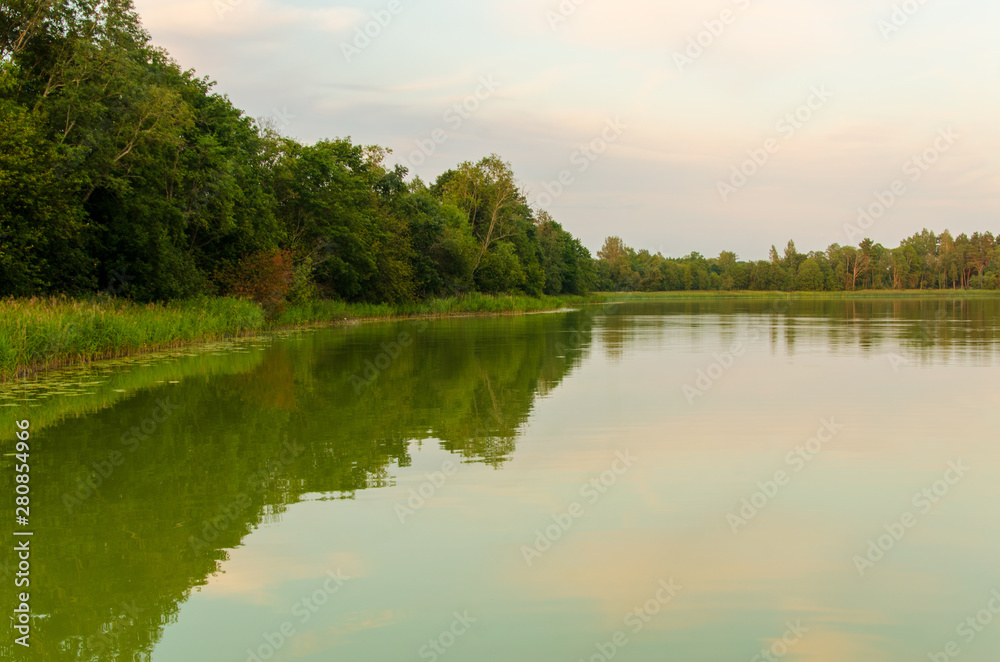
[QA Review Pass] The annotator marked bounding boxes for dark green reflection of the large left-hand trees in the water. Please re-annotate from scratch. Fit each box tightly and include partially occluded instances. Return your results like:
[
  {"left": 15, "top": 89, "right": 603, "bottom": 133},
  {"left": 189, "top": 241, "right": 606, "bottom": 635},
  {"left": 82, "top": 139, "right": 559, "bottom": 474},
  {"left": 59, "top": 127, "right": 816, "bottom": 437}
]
[{"left": 0, "top": 313, "right": 590, "bottom": 660}]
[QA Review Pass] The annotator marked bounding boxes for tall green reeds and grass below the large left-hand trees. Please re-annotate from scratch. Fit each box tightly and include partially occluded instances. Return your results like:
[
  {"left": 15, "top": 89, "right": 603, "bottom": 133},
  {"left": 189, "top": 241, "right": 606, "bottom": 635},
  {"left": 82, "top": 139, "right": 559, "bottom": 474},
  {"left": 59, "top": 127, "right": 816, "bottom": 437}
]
[{"left": 0, "top": 294, "right": 599, "bottom": 381}]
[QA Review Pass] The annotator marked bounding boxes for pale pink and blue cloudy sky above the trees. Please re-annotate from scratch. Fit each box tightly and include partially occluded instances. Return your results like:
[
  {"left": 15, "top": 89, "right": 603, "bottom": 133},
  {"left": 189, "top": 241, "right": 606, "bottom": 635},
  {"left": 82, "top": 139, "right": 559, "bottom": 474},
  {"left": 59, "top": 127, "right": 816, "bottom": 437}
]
[{"left": 135, "top": 0, "right": 1000, "bottom": 259}]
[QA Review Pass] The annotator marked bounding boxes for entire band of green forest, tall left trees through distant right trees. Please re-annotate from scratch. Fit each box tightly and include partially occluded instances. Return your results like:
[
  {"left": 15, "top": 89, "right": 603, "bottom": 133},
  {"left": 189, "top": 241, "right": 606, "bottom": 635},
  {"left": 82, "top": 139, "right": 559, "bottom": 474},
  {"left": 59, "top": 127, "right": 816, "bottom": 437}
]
[{"left": 0, "top": 0, "right": 1000, "bottom": 303}]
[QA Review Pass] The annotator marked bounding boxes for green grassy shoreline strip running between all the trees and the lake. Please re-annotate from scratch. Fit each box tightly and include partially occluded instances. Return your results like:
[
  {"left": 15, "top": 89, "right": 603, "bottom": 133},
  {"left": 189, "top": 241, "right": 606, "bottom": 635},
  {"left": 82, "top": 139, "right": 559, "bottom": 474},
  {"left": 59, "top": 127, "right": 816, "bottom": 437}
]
[{"left": 0, "top": 290, "right": 1000, "bottom": 384}]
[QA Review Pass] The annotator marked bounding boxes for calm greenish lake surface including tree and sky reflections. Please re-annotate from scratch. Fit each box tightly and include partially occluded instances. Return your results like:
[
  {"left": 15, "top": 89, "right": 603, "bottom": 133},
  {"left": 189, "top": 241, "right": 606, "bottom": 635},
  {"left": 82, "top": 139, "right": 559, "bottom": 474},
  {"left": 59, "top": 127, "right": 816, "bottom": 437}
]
[{"left": 0, "top": 299, "right": 1000, "bottom": 662}]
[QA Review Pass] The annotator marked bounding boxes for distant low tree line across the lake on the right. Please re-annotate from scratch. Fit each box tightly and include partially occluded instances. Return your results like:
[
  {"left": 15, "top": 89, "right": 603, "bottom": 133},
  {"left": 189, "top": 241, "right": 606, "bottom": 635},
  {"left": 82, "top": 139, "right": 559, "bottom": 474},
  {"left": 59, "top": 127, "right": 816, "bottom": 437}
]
[{"left": 595, "top": 229, "right": 1000, "bottom": 292}]
